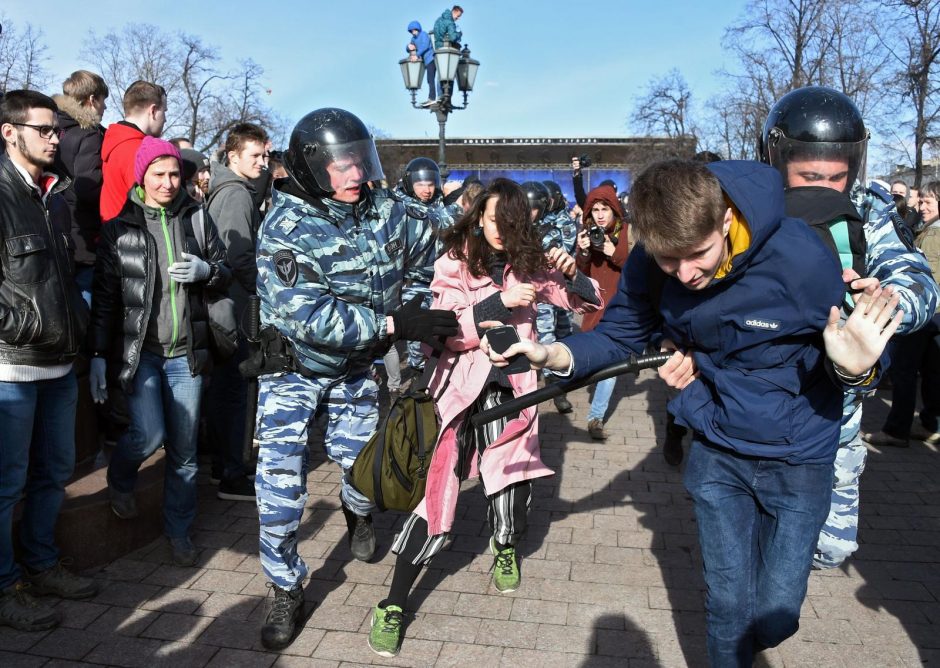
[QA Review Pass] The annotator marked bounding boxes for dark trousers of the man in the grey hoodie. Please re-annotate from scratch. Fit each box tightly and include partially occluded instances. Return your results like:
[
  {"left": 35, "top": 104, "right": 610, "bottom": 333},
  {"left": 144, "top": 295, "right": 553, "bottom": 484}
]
[{"left": 206, "top": 338, "right": 253, "bottom": 480}]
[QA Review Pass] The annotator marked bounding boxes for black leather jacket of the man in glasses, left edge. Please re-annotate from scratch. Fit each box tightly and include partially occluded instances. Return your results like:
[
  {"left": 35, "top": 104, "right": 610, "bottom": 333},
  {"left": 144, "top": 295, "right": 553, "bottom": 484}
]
[{"left": 0, "top": 154, "right": 88, "bottom": 366}]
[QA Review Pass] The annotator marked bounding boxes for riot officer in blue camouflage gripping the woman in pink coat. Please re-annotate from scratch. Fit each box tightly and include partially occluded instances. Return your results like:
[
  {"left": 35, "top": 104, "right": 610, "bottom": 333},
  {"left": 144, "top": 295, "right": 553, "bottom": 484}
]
[{"left": 251, "top": 108, "right": 457, "bottom": 649}]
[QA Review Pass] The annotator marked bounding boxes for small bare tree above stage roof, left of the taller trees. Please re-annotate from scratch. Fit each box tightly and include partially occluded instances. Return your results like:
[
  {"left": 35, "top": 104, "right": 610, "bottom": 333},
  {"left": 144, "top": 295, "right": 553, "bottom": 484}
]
[{"left": 630, "top": 69, "right": 695, "bottom": 138}]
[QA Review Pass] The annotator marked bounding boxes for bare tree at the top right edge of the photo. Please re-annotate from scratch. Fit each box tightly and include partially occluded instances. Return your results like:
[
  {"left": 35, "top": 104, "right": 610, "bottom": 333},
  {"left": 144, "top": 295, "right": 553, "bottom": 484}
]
[{"left": 882, "top": 0, "right": 940, "bottom": 188}]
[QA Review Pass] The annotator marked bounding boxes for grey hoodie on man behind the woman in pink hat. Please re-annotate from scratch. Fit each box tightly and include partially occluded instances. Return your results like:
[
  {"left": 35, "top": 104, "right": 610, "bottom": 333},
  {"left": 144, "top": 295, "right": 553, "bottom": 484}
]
[{"left": 208, "top": 163, "right": 261, "bottom": 320}]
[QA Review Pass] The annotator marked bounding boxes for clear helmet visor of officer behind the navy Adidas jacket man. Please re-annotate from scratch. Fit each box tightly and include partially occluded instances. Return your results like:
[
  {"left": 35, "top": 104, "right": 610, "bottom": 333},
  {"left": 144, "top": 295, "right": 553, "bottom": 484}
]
[{"left": 767, "top": 136, "right": 868, "bottom": 193}]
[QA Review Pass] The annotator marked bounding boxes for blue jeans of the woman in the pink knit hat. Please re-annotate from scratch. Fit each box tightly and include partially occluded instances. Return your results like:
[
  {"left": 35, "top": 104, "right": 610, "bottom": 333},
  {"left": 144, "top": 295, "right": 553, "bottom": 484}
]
[{"left": 108, "top": 351, "right": 202, "bottom": 538}]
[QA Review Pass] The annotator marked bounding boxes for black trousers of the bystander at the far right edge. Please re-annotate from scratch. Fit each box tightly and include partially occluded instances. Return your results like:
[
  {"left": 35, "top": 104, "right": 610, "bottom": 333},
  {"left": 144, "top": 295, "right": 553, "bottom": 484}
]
[{"left": 883, "top": 322, "right": 940, "bottom": 438}]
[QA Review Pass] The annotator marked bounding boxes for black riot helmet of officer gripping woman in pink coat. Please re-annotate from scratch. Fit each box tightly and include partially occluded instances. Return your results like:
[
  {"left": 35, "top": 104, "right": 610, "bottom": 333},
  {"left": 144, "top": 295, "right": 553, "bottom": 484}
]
[{"left": 284, "top": 107, "right": 385, "bottom": 197}]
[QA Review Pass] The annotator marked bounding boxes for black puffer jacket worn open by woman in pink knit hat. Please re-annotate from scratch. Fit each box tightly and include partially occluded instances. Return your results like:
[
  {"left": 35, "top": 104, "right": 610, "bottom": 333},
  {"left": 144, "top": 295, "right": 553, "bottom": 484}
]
[{"left": 90, "top": 190, "right": 232, "bottom": 393}]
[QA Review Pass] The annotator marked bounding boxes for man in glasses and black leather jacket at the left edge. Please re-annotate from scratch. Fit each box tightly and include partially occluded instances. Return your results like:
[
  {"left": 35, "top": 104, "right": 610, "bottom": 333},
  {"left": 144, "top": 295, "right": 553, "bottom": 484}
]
[{"left": 0, "top": 90, "right": 97, "bottom": 631}]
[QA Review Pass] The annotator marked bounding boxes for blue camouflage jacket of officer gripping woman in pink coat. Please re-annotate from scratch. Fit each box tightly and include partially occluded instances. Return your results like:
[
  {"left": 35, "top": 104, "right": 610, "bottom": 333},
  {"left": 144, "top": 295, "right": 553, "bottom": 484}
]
[{"left": 258, "top": 185, "right": 434, "bottom": 378}]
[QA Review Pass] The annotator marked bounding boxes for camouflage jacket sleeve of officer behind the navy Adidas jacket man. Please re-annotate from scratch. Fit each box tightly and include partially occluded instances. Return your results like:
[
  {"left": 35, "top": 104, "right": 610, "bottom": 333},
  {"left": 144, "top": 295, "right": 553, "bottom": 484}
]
[{"left": 852, "top": 183, "right": 940, "bottom": 334}]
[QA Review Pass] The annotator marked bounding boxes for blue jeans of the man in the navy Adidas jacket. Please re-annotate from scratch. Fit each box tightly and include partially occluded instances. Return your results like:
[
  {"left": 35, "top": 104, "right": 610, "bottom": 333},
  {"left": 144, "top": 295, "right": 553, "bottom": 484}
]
[{"left": 685, "top": 438, "right": 832, "bottom": 668}]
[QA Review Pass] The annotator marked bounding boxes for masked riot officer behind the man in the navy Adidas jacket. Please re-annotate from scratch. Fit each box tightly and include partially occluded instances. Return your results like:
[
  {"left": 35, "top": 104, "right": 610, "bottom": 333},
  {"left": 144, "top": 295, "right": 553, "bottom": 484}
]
[{"left": 760, "top": 86, "right": 938, "bottom": 568}]
